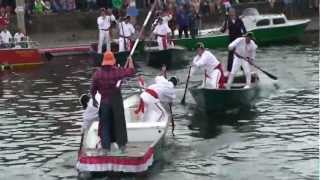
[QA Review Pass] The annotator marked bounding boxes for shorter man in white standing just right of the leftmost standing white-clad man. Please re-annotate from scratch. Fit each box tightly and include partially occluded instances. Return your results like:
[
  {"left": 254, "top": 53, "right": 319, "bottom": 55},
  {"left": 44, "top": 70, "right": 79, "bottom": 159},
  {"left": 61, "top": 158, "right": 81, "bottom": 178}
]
[{"left": 119, "top": 16, "right": 135, "bottom": 52}]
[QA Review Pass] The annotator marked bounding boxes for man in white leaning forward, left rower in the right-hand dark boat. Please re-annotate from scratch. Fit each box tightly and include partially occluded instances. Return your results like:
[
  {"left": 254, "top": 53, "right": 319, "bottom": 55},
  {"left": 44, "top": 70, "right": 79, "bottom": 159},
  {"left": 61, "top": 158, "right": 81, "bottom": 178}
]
[{"left": 191, "top": 42, "right": 224, "bottom": 89}]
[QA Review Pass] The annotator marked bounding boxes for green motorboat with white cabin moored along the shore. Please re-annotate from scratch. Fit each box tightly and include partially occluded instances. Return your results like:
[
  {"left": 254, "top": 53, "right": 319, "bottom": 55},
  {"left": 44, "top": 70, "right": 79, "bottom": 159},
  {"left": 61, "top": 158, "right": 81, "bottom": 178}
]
[{"left": 174, "top": 8, "right": 310, "bottom": 49}]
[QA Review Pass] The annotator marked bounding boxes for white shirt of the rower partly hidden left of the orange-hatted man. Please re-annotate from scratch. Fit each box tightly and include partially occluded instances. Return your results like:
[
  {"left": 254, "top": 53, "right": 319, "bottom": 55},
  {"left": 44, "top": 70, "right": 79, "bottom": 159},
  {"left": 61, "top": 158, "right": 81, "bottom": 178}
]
[{"left": 82, "top": 93, "right": 101, "bottom": 129}]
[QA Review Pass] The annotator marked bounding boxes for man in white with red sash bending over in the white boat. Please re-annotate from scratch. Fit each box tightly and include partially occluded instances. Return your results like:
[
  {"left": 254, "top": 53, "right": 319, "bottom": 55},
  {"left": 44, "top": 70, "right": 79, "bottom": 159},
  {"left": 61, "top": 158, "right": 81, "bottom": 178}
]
[{"left": 135, "top": 68, "right": 178, "bottom": 121}]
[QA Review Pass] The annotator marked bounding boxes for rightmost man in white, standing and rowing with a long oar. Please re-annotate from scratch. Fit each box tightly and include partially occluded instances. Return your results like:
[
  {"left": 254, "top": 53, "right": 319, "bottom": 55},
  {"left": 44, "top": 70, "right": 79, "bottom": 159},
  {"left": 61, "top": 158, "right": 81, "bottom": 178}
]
[{"left": 226, "top": 32, "right": 258, "bottom": 89}]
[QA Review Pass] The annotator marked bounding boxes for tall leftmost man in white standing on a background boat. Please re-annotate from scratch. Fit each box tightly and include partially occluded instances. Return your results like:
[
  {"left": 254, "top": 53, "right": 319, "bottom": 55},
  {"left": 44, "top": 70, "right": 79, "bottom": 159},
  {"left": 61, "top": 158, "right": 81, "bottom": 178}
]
[{"left": 97, "top": 8, "right": 117, "bottom": 53}]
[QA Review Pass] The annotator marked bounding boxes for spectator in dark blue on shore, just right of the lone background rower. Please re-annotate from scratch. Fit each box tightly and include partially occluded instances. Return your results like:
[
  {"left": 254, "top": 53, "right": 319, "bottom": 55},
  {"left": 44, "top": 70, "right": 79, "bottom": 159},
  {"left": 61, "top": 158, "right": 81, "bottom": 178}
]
[{"left": 176, "top": 5, "right": 189, "bottom": 38}]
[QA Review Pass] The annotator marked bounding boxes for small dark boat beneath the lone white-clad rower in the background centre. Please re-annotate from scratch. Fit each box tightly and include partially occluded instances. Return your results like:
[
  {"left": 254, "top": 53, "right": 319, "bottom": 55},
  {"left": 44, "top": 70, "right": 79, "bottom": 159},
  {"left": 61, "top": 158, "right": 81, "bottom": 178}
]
[{"left": 145, "top": 46, "right": 188, "bottom": 68}]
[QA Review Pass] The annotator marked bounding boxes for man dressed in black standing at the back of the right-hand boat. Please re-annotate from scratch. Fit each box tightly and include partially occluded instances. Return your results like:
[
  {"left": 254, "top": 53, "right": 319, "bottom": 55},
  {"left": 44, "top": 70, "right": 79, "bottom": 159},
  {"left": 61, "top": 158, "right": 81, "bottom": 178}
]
[{"left": 221, "top": 8, "right": 247, "bottom": 72}]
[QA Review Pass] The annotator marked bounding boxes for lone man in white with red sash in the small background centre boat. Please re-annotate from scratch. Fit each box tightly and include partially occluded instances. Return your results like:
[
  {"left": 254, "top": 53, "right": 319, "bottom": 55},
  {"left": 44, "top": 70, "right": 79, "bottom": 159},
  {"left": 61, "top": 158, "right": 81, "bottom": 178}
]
[{"left": 153, "top": 18, "right": 171, "bottom": 50}]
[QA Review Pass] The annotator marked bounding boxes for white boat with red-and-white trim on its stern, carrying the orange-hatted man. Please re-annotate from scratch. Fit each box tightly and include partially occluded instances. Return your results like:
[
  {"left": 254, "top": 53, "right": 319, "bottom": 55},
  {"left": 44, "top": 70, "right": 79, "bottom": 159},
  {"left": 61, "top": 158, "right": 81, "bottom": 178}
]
[{"left": 76, "top": 95, "right": 170, "bottom": 173}]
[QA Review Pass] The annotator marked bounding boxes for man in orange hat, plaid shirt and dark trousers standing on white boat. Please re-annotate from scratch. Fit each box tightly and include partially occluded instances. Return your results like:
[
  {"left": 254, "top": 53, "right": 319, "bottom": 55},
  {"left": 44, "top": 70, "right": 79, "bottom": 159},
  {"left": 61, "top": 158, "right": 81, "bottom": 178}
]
[{"left": 90, "top": 51, "right": 135, "bottom": 152}]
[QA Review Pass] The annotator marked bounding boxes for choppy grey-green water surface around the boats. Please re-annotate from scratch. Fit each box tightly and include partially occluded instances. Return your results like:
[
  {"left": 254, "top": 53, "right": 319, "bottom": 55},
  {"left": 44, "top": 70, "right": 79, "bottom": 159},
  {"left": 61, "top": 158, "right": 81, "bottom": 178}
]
[{"left": 0, "top": 46, "right": 319, "bottom": 180}]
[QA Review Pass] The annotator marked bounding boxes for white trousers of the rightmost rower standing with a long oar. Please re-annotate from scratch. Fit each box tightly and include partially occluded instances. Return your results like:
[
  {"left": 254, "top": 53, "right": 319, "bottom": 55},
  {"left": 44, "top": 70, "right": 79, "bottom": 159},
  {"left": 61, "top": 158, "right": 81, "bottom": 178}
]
[{"left": 227, "top": 56, "right": 251, "bottom": 88}]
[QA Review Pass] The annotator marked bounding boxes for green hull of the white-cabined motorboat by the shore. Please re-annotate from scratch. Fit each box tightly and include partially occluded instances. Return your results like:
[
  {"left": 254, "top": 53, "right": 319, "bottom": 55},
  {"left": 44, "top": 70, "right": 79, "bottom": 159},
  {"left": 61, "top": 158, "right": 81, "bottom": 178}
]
[{"left": 174, "top": 21, "right": 309, "bottom": 49}]
